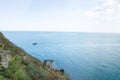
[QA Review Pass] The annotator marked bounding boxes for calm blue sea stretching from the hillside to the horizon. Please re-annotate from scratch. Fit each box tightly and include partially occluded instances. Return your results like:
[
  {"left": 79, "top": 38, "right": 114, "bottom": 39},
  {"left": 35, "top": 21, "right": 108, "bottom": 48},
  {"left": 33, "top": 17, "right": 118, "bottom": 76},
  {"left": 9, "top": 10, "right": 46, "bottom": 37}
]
[{"left": 3, "top": 32, "right": 120, "bottom": 80}]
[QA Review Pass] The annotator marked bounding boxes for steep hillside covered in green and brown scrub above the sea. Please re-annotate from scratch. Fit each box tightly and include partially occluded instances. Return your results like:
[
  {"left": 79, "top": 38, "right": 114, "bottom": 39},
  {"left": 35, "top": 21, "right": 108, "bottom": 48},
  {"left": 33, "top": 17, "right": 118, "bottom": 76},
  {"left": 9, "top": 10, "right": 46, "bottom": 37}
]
[{"left": 0, "top": 32, "right": 70, "bottom": 80}]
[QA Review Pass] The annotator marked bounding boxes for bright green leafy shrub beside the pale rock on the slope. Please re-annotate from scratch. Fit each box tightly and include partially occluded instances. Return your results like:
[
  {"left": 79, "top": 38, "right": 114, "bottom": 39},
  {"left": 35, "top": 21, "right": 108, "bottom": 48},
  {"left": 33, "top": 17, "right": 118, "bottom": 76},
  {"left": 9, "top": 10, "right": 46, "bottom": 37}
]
[{"left": 7, "top": 55, "right": 27, "bottom": 80}]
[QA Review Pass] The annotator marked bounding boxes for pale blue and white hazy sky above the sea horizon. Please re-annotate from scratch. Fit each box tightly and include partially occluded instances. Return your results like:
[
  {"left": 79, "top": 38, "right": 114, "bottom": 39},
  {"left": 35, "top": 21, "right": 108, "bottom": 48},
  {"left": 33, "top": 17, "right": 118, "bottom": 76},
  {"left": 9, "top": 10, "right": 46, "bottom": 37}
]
[{"left": 0, "top": 0, "right": 120, "bottom": 33}]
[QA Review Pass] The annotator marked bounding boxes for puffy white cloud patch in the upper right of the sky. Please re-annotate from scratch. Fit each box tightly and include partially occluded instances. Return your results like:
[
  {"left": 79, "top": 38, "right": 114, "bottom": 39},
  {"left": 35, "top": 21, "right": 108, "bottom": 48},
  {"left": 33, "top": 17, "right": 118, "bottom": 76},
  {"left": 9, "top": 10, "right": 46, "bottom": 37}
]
[{"left": 85, "top": 0, "right": 120, "bottom": 18}]
